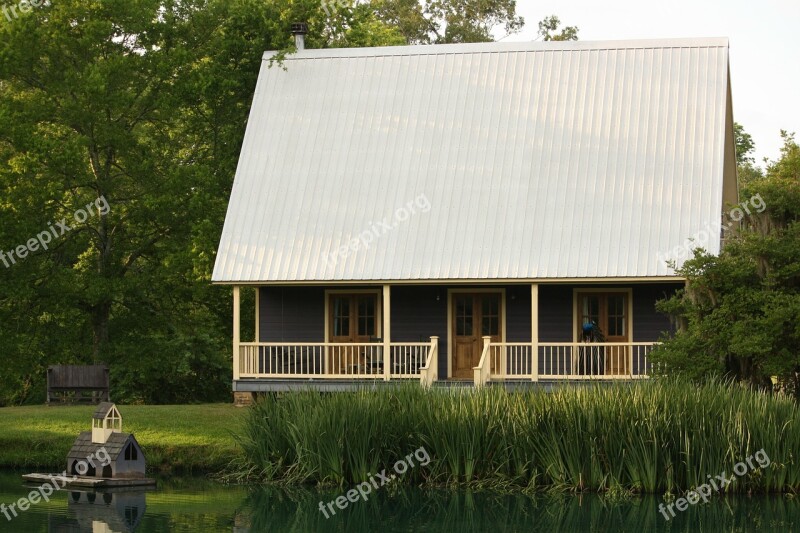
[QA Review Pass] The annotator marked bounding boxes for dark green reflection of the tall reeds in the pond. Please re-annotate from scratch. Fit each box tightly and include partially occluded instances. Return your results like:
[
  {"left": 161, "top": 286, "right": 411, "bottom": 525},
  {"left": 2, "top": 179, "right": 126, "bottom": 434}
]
[{"left": 246, "top": 488, "right": 800, "bottom": 533}]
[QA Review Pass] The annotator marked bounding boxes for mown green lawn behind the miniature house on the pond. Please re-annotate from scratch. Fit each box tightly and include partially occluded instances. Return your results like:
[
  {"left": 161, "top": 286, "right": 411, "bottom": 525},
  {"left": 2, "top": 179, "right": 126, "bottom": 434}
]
[{"left": 0, "top": 404, "right": 246, "bottom": 474}]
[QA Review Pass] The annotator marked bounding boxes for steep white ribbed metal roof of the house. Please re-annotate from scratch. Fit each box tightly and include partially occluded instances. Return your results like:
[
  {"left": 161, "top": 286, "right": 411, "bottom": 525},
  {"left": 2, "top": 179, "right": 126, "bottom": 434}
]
[{"left": 213, "top": 39, "right": 736, "bottom": 283}]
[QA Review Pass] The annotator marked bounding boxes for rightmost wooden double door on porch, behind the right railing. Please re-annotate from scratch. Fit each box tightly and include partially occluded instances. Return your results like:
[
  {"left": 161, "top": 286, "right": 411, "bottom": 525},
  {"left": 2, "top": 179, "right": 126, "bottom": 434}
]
[{"left": 578, "top": 292, "right": 629, "bottom": 375}]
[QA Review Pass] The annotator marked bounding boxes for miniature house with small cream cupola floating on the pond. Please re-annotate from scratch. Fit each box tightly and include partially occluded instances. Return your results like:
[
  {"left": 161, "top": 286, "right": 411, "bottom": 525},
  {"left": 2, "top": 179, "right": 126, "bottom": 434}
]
[{"left": 67, "top": 402, "right": 146, "bottom": 479}]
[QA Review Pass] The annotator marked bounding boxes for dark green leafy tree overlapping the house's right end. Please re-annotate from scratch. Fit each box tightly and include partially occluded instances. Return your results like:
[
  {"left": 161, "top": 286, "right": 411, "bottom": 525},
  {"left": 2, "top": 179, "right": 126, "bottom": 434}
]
[{"left": 652, "top": 132, "right": 800, "bottom": 397}]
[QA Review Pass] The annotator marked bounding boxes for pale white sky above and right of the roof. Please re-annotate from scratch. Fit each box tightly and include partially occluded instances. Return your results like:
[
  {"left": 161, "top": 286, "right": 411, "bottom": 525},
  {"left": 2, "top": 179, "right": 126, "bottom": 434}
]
[{"left": 503, "top": 0, "right": 800, "bottom": 166}]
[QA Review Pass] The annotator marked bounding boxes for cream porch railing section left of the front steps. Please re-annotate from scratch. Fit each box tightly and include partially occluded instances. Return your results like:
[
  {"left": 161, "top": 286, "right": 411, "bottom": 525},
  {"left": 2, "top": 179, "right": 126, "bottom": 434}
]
[{"left": 234, "top": 338, "right": 438, "bottom": 380}]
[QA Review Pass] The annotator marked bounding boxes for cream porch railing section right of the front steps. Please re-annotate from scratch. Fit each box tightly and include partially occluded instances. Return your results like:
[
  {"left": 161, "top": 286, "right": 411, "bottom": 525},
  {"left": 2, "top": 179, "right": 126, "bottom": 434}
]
[{"left": 475, "top": 342, "right": 658, "bottom": 385}]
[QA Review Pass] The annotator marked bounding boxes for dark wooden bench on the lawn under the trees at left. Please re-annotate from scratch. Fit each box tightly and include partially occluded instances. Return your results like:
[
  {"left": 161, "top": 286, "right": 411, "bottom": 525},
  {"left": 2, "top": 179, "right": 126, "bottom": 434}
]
[{"left": 47, "top": 365, "right": 109, "bottom": 405}]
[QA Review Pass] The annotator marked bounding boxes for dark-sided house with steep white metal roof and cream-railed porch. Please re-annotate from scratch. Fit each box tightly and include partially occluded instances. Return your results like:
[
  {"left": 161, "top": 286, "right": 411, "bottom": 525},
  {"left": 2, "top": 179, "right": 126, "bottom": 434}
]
[{"left": 213, "top": 38, "right": 738, "bottom": 392}]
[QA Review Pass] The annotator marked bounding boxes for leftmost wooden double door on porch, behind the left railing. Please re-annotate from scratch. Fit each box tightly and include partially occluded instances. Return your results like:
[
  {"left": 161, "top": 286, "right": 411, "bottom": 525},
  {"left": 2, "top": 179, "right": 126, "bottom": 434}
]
[{"left": 328, "top": 293, "right": 382, "bottom": 374}]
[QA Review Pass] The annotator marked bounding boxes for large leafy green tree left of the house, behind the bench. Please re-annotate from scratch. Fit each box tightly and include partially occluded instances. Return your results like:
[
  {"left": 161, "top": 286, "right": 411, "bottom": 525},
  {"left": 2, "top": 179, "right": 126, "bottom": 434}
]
[{"left": 0, "top": 0, "right": 238, "bottom": 399}]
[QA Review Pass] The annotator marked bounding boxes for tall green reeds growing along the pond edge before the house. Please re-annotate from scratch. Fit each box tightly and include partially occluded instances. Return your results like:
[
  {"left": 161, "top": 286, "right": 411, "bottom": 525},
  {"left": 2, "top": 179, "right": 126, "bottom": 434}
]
[{"left": 237, "top": 379, "right": 800, "bottom": 493}]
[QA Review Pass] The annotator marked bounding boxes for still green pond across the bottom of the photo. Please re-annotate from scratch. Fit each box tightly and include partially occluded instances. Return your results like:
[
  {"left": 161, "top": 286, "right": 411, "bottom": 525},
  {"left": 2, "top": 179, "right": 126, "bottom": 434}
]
[{"left": 0, "top": 472, "right": 800, "bottom": 533}]
